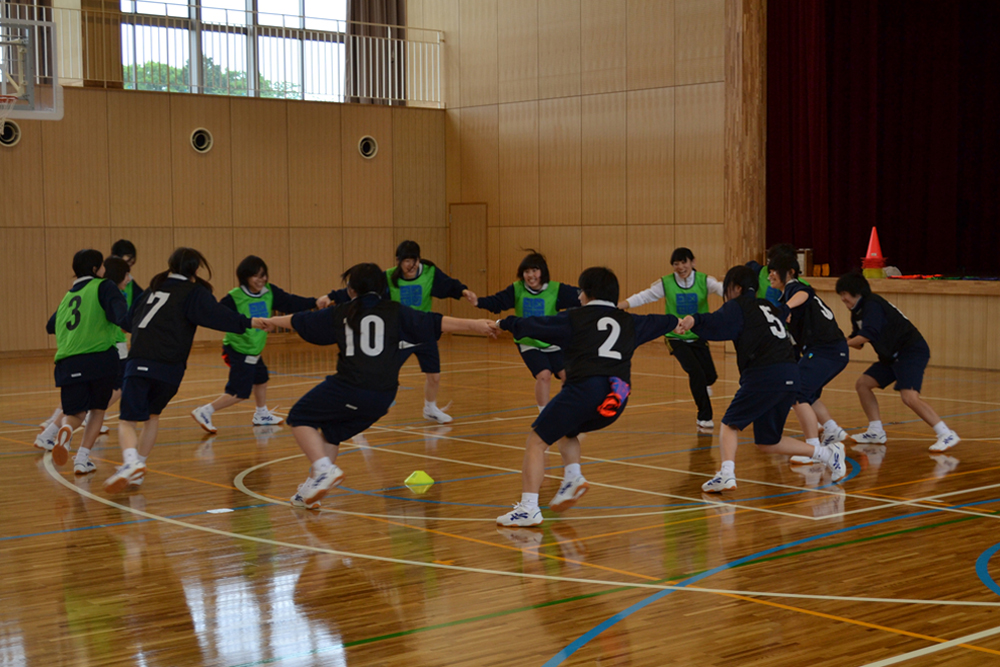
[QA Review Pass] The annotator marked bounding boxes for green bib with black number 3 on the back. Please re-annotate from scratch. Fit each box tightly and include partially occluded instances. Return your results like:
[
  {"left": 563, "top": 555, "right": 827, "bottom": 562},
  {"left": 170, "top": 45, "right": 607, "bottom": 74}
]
[{"left": 56, "top": 278, "right": 121, "bottom": 361}]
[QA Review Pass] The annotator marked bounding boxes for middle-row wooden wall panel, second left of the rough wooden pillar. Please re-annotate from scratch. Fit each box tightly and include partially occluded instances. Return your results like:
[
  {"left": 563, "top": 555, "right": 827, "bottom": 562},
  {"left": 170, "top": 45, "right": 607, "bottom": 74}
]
[{"left": 627, "top": 88, "right": 674, "bottom": 225}]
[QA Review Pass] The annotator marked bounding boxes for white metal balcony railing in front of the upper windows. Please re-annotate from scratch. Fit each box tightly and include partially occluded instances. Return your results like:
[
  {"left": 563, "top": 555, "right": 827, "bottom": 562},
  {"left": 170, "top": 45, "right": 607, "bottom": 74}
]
[{"left": 0, "top": 2, "right": 444, "bottom": 107}]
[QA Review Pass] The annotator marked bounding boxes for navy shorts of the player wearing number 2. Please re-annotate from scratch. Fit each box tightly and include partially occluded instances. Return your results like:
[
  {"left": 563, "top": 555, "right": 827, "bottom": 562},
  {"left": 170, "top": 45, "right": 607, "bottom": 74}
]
[{"left": 531, "top": 377, "right": 628, "bottom": 445}]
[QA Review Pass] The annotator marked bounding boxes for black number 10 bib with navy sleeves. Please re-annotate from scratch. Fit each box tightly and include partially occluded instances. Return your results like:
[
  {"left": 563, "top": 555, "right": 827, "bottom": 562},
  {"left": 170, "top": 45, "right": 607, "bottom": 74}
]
[{"left": 292, "top": 294, "right": 442, "bottom": 392}]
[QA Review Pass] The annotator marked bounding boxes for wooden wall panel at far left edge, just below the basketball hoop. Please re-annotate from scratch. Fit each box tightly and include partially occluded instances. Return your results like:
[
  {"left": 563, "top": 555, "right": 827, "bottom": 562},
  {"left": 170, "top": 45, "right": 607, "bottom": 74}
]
[{"left": 0, "top": 120, "right": 45, "bottom": 227}]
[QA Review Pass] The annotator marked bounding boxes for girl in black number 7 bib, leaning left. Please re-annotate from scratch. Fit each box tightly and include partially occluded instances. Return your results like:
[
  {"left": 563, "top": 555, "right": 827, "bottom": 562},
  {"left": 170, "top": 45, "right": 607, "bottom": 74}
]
[{"left": 104, "top": 248, "right": 264, "bottom": 493}]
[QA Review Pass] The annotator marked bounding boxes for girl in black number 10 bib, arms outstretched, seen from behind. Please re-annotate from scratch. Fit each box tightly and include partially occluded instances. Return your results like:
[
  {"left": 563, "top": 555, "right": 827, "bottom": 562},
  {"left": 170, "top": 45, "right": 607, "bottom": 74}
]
[{"left": 256, "top": 264, "right": 496, "bottom": 509}]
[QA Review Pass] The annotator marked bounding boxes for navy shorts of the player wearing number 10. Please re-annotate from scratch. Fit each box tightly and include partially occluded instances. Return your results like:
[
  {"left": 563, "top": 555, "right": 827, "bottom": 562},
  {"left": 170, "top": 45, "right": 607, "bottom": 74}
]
[{"left": 285, "top": 375, "right": 396, "bottom": 445}]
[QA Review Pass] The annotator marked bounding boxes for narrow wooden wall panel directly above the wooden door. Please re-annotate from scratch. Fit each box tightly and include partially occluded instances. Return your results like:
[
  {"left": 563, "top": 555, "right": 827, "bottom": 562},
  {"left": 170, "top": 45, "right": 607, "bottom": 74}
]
[{"left": 461, "top": 105, "right": 500, "bottom": 225}]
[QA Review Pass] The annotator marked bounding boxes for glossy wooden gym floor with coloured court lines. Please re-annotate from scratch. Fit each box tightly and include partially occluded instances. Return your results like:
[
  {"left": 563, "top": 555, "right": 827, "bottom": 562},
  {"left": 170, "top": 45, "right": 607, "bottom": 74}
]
[{"left": 0, "top": 337, "right": 1000, "bottom": 667}]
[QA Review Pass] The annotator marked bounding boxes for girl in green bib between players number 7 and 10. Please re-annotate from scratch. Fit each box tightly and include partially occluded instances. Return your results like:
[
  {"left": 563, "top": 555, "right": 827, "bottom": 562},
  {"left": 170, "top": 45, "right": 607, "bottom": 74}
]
[{"left": 191, "top": 255, "right": 316, "bottom": 433}]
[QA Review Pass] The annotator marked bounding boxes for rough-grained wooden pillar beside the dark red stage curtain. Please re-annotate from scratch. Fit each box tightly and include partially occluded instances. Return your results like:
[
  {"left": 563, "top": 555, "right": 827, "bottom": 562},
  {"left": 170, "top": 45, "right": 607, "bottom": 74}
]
[{"left": 723, "top": 0, "right": 767, "bottom": 266}]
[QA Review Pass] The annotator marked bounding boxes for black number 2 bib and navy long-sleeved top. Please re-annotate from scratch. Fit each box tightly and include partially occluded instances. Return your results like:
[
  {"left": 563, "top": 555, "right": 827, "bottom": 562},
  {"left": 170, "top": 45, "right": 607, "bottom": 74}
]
[{"left": 500, "top": 301, "right": 677, "bottom": 384}]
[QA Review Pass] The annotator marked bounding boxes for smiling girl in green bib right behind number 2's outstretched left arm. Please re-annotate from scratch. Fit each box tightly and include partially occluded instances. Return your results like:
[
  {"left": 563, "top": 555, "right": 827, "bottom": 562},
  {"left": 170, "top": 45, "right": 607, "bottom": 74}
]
[{"left": 468, "top": 250, "right": 580, "bottom": 412}]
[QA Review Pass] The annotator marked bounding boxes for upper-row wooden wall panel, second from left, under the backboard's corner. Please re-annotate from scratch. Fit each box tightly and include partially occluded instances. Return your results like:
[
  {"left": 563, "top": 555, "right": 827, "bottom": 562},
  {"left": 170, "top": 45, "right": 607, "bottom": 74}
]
[{"left": 42, "top": 88, "right": 111, "bottom": 227}]
